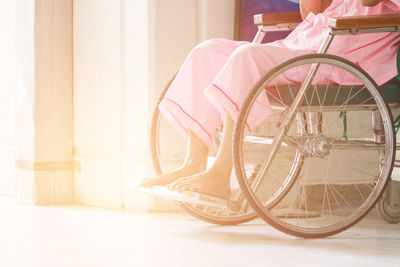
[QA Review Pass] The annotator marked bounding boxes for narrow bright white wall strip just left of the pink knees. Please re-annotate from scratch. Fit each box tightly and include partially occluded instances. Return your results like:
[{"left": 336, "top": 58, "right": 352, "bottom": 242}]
[{"left": 121, "top": 0, "right": 156, "bottom": 210}]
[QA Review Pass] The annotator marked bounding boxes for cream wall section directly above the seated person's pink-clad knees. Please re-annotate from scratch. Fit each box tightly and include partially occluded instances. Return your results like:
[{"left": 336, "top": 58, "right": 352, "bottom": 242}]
[{"left": 153, "top": 0, "right": 235, "bottom": 95}]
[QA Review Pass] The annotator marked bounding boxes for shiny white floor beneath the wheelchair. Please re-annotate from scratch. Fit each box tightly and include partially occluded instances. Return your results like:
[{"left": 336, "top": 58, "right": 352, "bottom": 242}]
[{"left": 0, "top": 198, "right": 400, "bottom": 267}]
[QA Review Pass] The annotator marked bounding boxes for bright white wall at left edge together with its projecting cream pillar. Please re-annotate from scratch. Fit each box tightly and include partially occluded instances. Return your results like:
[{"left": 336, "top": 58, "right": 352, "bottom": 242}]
[{"left": 0, "top": 0, "right": 72, "bottom": 204}]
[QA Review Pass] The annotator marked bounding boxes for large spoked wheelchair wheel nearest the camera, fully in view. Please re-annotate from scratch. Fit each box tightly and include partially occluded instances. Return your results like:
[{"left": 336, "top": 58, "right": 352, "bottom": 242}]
[{"left": 233, "top": 54, "right": 396, "bottom": 238}]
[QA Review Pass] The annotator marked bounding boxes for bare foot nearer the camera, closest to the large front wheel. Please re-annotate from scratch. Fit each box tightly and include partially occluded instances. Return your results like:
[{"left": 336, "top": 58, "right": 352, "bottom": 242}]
[{"left": 168, "top": 168, "right": 231, "bottom": 199}]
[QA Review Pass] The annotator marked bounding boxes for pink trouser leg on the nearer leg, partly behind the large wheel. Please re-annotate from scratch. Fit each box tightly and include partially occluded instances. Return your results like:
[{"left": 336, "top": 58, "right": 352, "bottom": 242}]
[{"left": 206, "top": 43, "right": 312, "bottom": 129}]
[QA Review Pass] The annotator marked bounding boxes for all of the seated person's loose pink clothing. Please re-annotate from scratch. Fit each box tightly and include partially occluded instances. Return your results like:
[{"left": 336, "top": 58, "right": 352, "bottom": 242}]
[{"left": 159, "top": 0, "right": 400, "bottom": 149}]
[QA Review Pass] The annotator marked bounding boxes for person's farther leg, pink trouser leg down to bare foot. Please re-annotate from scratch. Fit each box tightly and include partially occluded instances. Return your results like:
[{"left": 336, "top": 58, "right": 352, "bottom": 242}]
[{"left": 141, "top": 39, "right": 244, "bottom": 187}]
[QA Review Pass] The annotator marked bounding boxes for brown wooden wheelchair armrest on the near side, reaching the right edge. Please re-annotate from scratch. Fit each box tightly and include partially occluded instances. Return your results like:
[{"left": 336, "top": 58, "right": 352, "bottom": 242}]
[{"left": 328, "top": 14, "right": 400, "bottom": 30}]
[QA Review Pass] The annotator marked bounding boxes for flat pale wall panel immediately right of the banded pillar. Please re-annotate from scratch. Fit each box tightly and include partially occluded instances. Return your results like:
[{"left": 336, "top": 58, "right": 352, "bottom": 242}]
[{"left": 73, "top": 0, "right": 122, "bottom": 207}]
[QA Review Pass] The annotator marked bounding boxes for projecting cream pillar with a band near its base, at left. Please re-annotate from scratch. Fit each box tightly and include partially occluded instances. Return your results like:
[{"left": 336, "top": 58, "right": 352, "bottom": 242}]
[{"left": 11, "top": 0, "right": 73, "bottom": 204}]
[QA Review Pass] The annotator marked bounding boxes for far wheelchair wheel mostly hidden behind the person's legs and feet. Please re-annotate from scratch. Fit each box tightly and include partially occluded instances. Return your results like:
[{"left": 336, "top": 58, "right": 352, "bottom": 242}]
[{"left": 150, "top": 73, "right": 256, "bottom": 225}]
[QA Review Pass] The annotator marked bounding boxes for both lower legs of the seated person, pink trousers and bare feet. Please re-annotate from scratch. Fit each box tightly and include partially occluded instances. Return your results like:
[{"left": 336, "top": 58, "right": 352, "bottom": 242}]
[{"left": 143, "top": 43, "right": 310, "bottom": 192}]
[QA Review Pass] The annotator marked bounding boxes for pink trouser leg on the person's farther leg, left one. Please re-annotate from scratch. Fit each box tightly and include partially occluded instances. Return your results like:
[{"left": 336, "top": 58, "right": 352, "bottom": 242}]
[{"left": 159, "top": 39, "right": 244, "bottom": 149}]
